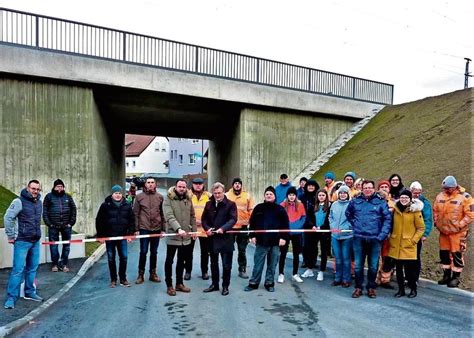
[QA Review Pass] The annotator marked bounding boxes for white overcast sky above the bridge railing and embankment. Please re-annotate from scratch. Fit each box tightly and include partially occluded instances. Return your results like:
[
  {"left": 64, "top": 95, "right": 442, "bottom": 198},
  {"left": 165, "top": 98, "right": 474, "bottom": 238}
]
[{"left": 0, "top": 0, "right": 474, "bottom": 103}]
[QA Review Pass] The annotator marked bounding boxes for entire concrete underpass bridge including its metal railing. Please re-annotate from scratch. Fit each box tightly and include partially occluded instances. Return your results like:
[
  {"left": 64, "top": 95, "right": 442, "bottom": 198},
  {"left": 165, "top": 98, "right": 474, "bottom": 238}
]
[{"left": 0, "top": 8, "right": 393, "bottom": 234}]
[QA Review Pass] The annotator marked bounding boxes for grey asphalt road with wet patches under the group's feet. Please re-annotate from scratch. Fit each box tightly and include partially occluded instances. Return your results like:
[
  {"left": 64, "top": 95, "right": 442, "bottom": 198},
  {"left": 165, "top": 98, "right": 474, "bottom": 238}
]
[{"left": 11, "top": 242, "right": 474, "bottom": 337}]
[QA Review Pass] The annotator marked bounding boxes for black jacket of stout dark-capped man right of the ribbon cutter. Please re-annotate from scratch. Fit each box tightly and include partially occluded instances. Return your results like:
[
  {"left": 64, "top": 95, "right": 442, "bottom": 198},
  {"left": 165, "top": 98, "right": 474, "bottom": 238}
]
[{"left": 249, "top": 202, "right": 290, "bottom": 246}]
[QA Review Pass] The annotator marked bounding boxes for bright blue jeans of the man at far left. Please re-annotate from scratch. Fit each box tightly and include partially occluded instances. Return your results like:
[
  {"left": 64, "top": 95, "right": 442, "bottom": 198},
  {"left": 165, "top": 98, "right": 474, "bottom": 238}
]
[{"left": 7, "top": 241, "right": 40, "bottom": 300}]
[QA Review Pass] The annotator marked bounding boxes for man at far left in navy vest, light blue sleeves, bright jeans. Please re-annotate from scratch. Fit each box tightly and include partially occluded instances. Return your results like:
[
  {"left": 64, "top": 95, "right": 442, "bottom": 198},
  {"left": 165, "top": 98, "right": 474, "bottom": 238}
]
[{"left": 3, "top": 180, "right": 43, "bottom": 309}]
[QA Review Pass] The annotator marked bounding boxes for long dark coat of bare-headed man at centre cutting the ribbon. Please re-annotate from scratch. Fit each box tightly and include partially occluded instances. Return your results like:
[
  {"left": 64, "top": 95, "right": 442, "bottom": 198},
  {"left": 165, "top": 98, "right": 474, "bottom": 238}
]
[{"left": 201, "top": 196, "right": 237, "bottom": 253}]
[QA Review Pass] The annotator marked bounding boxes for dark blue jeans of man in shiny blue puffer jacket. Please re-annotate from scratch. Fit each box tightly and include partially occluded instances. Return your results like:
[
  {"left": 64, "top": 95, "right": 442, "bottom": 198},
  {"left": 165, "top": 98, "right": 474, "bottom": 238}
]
[{"left": 353, "top": 237, "right": 382, "bottom": 289}]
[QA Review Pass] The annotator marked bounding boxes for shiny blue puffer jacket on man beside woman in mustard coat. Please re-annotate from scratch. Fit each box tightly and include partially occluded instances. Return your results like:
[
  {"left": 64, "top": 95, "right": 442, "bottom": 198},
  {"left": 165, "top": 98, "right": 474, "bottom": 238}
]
[{"left": 346, "top": 193, "right": 392, "bottom": 241}]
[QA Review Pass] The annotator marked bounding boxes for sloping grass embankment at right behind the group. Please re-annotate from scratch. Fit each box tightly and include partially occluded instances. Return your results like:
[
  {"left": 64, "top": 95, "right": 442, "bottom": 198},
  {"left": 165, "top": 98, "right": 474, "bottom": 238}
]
[{"left": 314, "top": 88, "right": 474, "bottom": 290}]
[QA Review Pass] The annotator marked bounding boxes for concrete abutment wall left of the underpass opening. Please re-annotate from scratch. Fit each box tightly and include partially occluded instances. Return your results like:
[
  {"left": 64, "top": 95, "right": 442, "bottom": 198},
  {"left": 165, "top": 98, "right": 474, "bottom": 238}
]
[{"left": 0, "top": 77, "right": 125, "bottom": 235}]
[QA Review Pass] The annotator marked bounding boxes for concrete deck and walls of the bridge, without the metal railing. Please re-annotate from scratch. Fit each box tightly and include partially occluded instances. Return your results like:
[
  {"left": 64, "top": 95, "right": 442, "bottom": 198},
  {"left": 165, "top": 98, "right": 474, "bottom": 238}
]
[{"left": 0, "top": 45, "right": 382, "bottom": 234}]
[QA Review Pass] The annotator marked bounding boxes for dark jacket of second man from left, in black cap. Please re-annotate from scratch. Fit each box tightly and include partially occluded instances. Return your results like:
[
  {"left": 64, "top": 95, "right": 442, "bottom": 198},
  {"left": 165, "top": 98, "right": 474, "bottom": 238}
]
[{"left": 43, "top": 190, "right": 77, "bottom": 228}]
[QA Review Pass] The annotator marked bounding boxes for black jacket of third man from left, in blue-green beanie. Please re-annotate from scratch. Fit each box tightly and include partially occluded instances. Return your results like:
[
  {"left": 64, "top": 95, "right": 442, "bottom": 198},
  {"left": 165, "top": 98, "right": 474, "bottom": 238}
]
[{"left": 95, "top": 196, "right": 135, "bottom": 237}]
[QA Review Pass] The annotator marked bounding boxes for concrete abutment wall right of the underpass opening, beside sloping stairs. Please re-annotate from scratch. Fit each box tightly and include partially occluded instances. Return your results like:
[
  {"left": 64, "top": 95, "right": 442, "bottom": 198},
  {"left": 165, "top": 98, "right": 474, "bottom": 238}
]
[{"left": 228, "top": 108, "right": 353, "bottom": 201}]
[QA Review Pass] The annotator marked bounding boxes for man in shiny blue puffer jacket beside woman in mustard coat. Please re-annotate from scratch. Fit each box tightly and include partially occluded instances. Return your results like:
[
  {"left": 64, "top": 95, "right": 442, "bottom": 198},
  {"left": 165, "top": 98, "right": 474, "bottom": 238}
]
[{"left": 346, "top": 180, "right": 392, "bottom": 298}]
